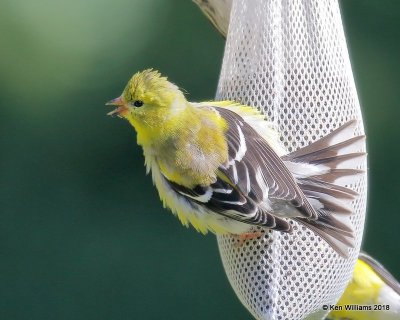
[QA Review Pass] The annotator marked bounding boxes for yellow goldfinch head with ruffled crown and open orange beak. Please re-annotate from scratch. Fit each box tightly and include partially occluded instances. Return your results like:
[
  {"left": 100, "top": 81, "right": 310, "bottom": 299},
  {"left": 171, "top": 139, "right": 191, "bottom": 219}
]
[{"left": 107, "top": 69, "right": 187, "bottom": 135}]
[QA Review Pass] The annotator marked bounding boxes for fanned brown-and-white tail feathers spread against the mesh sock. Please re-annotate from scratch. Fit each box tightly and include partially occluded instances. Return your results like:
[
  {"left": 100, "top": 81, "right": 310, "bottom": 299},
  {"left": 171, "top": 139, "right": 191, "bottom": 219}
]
[{"left": 282, "top": 120, "right": 366, "bottom": 257}]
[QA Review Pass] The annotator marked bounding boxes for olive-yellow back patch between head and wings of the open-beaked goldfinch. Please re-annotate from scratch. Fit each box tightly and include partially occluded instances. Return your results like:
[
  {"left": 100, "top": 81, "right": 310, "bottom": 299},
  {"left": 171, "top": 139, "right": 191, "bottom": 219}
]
[{"left": 154, "top": 108, "right": 228, "bottom": 188}]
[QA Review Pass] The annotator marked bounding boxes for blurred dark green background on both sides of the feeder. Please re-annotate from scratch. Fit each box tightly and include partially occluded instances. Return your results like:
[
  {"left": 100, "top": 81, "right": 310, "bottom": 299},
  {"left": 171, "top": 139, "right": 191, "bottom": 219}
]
[{"left": 0, "top": 0, "right": 400, "bottom": 320}]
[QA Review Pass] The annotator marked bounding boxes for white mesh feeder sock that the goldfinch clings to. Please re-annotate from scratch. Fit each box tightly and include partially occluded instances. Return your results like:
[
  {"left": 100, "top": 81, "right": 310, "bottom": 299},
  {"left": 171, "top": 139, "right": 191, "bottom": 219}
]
[{"left": 217, "top": 0, "right": 366, "bottom": 320}]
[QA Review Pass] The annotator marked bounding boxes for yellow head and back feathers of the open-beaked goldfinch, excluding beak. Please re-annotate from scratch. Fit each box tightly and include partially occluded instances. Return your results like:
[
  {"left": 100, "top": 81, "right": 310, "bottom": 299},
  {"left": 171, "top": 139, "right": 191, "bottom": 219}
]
[{"left": 117, "top": 70, "right": 227, "bottom": 188}]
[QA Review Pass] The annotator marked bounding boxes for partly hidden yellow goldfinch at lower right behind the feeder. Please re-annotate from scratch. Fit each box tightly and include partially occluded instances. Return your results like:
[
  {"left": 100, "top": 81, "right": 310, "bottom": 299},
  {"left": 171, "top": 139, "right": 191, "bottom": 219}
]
[{"left": 327, "top": 253, "right": 400, "bottom": 320}]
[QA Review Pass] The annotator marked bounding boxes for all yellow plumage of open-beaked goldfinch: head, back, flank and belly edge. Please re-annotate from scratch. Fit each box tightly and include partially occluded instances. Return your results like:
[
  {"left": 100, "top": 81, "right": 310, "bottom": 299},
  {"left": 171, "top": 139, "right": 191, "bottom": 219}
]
[{"left": 109, "top": 69, "right": 275, "bottom": 234}]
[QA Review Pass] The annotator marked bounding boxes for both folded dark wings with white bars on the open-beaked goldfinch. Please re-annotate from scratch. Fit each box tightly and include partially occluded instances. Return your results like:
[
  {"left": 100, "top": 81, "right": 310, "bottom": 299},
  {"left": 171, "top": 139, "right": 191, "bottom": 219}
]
[{"left": 162, "top": 107, "right": 317, "bottom": 231}]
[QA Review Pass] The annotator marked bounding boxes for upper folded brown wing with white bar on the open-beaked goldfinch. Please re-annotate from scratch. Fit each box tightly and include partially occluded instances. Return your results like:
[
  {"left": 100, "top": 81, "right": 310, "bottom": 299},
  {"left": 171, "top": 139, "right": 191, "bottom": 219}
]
[{"left": 216, "top": 108, "right": 318, "bottom": 219}]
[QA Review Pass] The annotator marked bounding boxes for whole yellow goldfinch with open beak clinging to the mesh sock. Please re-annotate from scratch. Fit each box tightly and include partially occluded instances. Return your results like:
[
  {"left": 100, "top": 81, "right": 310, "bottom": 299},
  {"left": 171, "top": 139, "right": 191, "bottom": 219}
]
[{"left": 107, "top": 69, "right": 365, "bottom": 256}]
